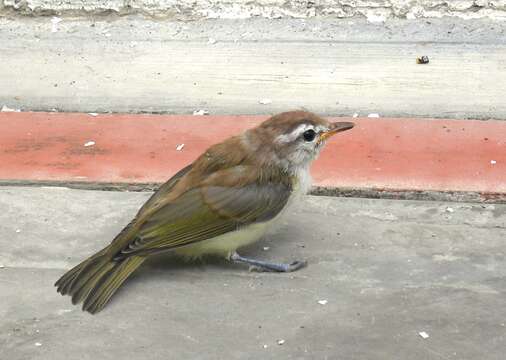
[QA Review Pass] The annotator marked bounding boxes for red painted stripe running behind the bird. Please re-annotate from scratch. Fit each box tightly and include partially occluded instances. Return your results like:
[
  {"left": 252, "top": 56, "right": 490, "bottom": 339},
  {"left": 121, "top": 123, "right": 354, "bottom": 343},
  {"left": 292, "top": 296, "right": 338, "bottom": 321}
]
[{"left": 0, "top": 113, "right": 506, "bottom": 193}]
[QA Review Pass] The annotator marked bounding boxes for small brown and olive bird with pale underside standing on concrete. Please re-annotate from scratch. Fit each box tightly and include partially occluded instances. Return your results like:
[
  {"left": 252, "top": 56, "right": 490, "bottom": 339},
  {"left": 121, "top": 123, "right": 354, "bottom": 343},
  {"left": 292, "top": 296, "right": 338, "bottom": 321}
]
[{"left": 55, "top": 110, "right": 354, "bottom": 314}]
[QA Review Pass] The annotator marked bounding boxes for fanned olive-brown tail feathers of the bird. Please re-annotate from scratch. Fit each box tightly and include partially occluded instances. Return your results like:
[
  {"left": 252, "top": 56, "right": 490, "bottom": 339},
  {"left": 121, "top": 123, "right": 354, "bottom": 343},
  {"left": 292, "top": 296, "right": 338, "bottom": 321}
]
[{"left": 55, "top": 248, "right": 145, "bottom": 314}]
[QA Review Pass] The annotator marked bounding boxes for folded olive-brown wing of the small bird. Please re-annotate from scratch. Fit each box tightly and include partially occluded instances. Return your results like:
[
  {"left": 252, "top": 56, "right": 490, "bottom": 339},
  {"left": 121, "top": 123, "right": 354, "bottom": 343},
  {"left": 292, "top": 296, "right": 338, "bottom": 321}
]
[{"left": 116, "top": 182, "right": 291, "bottom": 258}]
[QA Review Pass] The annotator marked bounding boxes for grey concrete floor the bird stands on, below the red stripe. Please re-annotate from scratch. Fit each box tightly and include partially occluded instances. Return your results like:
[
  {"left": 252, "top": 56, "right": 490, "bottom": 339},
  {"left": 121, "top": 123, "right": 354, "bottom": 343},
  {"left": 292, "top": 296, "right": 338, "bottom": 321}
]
[{"left": 0, "top": 187, "right": 506, "bottom": 360}]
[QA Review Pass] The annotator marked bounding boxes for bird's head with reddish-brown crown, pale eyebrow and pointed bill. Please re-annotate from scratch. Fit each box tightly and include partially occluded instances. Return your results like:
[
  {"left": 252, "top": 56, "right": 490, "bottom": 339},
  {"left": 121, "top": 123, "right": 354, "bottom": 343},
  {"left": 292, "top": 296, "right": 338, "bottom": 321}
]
[{"left": 247, "top": 111, "right": 354, "bottom": 172}]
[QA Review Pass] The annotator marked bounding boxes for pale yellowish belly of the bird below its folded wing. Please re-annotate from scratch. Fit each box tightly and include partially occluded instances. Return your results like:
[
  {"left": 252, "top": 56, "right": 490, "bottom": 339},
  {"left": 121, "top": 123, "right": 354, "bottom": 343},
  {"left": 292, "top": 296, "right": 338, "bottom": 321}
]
[{"left": 176, "top": 220, "right": 274, "bottom": 258}]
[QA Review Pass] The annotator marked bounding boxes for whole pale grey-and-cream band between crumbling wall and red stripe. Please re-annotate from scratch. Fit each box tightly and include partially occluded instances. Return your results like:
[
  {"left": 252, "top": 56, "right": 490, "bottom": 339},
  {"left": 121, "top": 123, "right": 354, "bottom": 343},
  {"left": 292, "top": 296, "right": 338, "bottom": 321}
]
[{"left": 0, "top": 17, "right": 506, "bottom": 119}]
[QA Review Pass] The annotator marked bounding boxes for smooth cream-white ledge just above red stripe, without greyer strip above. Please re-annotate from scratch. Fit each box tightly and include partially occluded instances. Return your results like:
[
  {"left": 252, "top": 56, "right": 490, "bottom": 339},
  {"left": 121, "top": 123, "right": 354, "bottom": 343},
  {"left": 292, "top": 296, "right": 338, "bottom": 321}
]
[{"left": 0, "top": 32, "right": 506, "bottom": 119}]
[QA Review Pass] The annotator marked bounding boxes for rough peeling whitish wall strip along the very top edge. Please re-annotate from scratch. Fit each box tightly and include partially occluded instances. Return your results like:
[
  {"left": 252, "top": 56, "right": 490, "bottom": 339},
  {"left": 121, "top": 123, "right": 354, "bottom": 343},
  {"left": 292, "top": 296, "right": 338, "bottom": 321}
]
[{"left": 0, "top": 0, "right": 506, "bottom": 21}]
